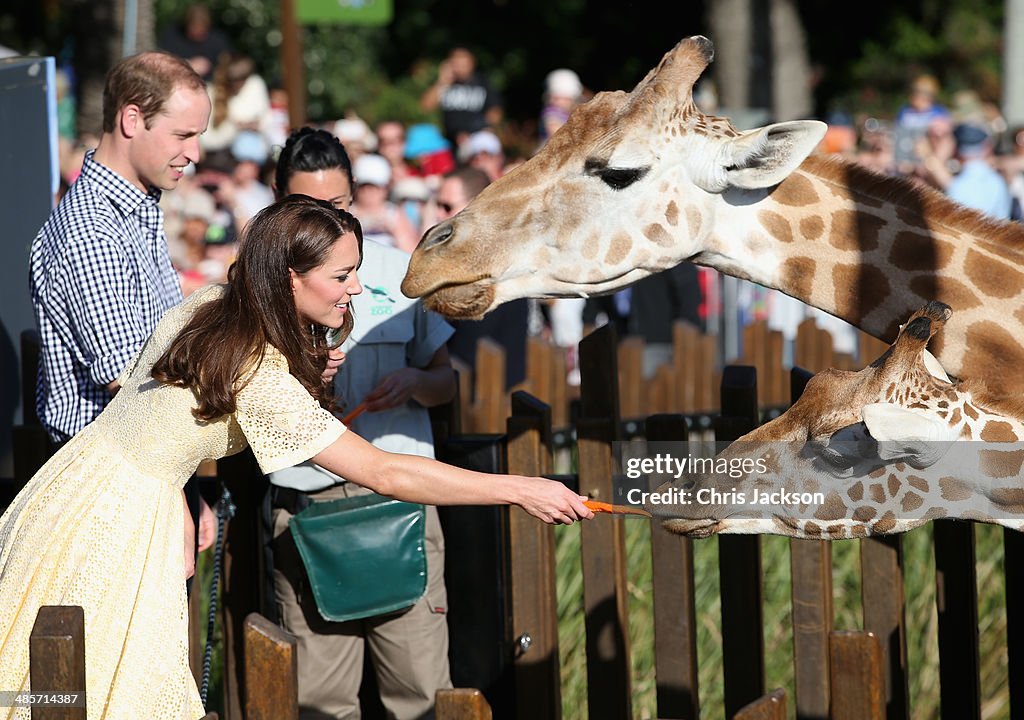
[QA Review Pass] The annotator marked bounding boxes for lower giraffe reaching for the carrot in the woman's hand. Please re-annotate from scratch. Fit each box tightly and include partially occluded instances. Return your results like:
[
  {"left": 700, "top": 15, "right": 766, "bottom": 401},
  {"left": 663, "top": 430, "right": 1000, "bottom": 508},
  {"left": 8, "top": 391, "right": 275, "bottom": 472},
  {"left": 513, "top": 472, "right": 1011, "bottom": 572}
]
[{"left": 647, "top": 302, "right": 1024, "bottom": 540}]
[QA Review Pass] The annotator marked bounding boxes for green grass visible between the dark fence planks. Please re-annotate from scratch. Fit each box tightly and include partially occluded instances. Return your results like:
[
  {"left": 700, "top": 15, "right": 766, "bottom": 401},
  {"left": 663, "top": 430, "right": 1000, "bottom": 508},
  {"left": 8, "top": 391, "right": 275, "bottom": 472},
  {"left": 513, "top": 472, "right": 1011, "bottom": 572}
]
[{"left": 556, "top": 520, "right": 1010, "bottom": 720}]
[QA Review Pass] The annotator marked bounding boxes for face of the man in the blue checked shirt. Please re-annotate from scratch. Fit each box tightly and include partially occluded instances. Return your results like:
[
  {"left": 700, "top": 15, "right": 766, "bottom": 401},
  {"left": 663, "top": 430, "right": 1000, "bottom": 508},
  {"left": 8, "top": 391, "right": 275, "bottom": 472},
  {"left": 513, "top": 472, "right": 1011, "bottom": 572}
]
[{"left": 130, "top": 88, "right": 210, "bottom": 190}]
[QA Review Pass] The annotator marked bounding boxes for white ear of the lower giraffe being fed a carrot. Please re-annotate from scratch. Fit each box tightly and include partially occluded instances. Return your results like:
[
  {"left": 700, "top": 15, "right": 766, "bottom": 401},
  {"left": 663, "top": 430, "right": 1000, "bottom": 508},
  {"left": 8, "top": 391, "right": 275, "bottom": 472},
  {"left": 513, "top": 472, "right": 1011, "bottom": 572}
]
[{"left": 860, "top": 403, "right": 956, "bottom": 468}]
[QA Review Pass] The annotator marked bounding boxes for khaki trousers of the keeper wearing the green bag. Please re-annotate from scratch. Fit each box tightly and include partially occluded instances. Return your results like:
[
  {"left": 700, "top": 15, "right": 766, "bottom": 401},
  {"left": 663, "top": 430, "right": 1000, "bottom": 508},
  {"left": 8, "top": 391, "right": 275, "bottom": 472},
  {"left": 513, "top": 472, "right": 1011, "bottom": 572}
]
[{"left": 271, "top": 483, "right": 452, "bottom": 720}]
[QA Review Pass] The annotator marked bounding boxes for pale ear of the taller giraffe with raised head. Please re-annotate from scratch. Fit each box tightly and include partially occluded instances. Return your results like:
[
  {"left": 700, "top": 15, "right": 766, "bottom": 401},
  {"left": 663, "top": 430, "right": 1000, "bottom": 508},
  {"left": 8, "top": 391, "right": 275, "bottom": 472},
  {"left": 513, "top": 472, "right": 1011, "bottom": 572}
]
[{"left": 720, "top": 120, "right": 828, "bottom": 189}]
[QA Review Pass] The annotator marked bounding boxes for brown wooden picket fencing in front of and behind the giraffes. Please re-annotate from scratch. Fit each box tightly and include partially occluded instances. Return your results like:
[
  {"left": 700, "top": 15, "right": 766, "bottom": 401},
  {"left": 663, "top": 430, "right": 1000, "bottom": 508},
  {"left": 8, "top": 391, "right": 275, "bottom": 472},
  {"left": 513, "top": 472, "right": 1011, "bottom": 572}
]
[{"left": 12, "top": 326, "right": 1024, "bottom": 720}]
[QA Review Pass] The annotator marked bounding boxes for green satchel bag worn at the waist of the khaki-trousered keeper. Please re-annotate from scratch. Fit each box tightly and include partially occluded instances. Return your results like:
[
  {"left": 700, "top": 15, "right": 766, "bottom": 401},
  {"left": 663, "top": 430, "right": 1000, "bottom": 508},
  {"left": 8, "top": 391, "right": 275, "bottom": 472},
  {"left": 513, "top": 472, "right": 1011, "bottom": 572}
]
[{"left": 289, "top": 495, "right": 427, "bottom": 623}]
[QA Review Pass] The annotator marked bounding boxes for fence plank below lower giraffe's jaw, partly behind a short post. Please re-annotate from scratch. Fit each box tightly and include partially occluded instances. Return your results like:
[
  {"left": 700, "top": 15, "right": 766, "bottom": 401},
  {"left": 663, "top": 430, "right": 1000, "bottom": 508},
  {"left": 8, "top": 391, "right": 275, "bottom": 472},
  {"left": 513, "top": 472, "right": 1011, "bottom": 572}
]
[{"left": 860, "top": 535, "right": 910, "bottom": 720}]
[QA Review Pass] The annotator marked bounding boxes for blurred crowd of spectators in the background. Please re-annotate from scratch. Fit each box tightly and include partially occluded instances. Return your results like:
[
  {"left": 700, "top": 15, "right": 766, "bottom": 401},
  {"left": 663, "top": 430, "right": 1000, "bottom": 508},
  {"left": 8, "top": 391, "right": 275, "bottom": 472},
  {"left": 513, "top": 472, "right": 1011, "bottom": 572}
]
[{"left": 51, "top": 16, "right": 1024, "bottom": 391}]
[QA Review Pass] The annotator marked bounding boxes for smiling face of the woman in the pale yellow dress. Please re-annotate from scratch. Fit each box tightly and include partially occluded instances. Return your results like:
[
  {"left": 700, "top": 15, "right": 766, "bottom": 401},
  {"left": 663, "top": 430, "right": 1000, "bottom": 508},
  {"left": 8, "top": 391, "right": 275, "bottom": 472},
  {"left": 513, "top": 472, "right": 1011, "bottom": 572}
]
[{"left": 289, "top": 232, "right": 362, "bottom": 329}]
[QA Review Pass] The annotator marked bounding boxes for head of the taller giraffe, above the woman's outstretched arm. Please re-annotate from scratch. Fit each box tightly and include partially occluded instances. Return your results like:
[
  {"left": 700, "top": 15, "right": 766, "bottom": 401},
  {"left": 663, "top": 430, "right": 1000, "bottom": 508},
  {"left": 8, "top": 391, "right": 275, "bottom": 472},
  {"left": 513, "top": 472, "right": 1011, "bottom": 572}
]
[{"left": 402, "top": 36, "right": 825, "bottom": 317}]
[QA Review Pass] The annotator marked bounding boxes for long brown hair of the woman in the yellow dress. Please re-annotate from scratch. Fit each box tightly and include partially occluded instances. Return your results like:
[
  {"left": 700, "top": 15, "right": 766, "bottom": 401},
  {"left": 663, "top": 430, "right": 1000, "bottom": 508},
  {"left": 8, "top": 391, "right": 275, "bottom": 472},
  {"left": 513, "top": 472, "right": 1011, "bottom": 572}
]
[{"left": 153, "top": 195, "right": 362, "bottom": 421}]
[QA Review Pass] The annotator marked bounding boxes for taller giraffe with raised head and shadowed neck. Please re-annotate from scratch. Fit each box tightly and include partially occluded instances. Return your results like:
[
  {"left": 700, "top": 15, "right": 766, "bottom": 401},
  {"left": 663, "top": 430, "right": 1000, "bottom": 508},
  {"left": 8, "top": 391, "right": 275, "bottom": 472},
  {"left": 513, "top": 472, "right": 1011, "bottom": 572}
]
[{"left": 402, "top": 36, "right": 1024, "bottom": 395}]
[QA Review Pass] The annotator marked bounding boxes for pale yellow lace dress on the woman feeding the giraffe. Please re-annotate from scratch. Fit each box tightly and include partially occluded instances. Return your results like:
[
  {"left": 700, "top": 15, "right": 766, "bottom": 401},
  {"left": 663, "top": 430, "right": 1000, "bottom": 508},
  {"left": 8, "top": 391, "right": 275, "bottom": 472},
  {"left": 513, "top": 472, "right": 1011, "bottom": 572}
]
[{"left": 0, "top": 286, "right": 345, "bottom": 720}]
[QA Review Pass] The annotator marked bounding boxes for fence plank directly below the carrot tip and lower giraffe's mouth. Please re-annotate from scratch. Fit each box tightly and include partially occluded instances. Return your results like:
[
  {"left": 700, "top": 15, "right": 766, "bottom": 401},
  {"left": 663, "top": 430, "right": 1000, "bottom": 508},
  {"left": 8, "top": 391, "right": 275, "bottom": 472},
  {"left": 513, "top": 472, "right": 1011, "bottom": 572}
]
[{"left": 646, "top": 415, "right": 700, "bottom": 720}]
